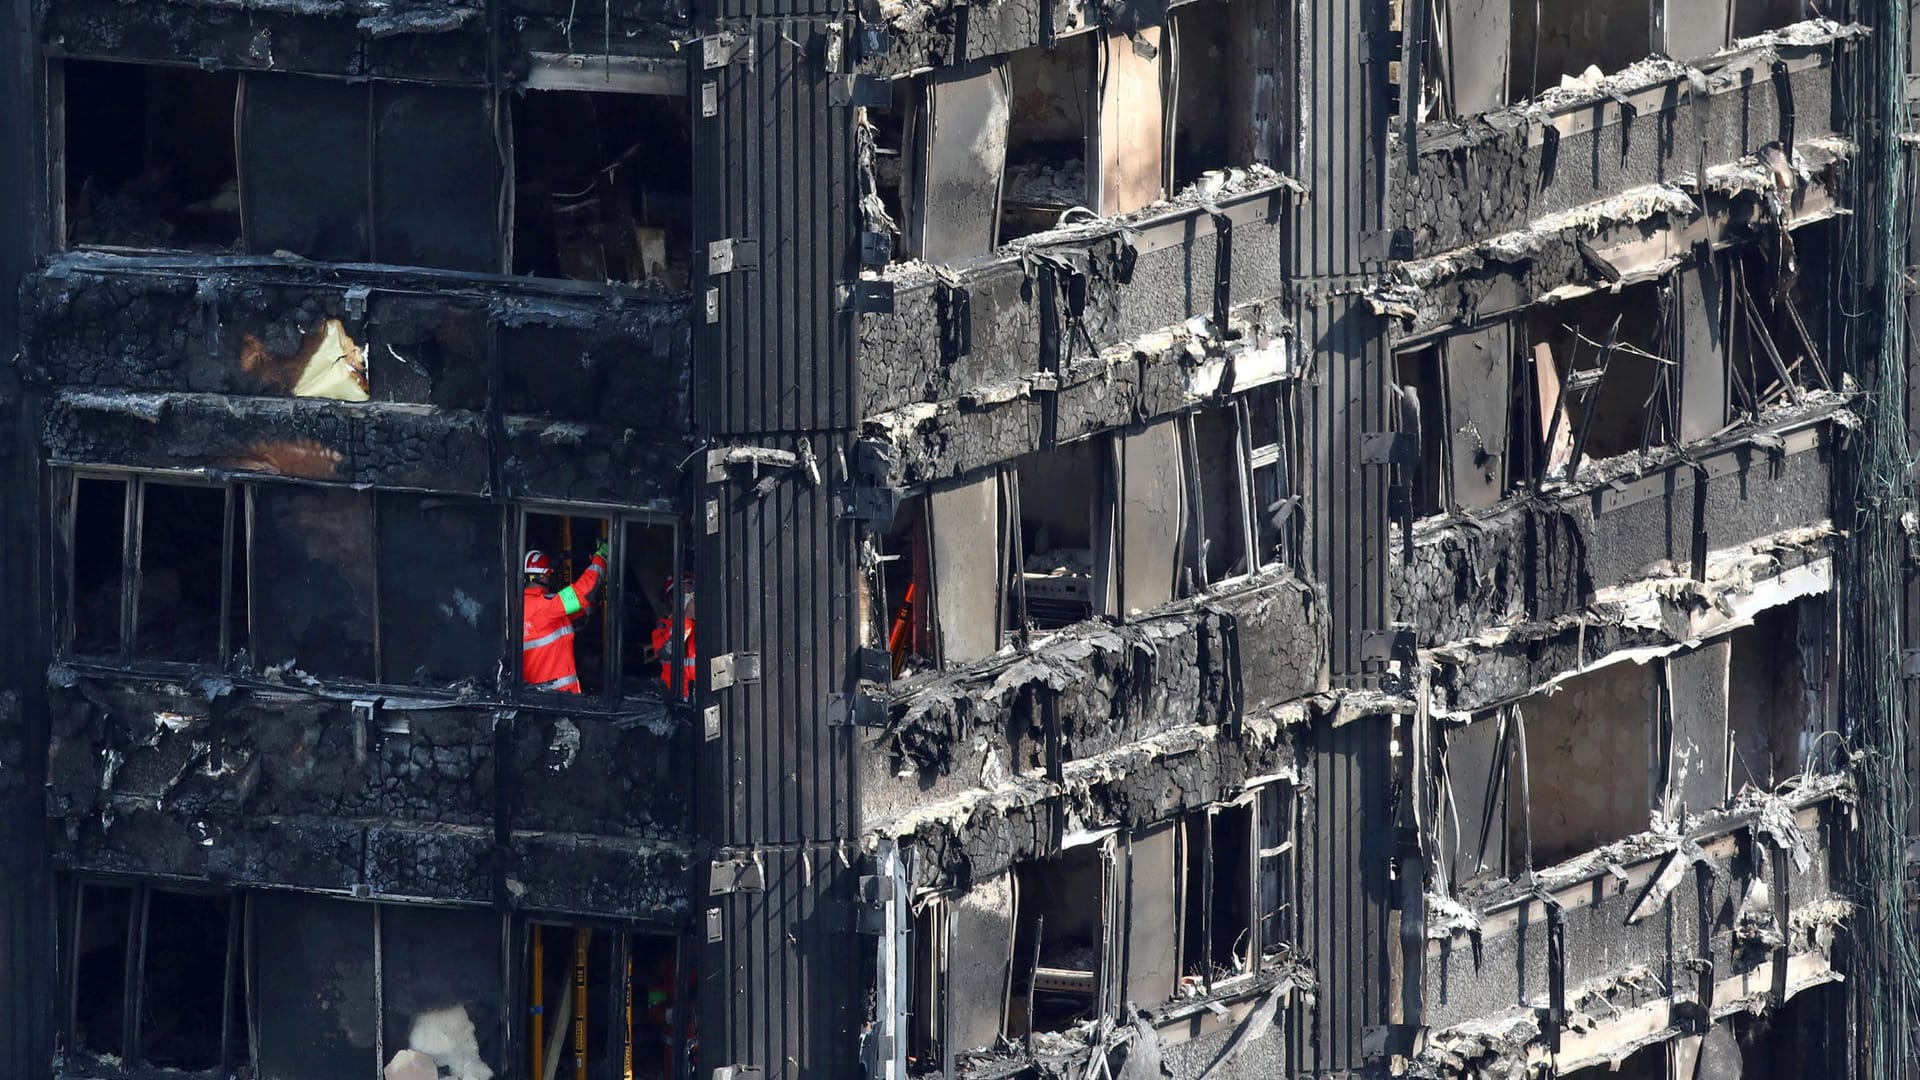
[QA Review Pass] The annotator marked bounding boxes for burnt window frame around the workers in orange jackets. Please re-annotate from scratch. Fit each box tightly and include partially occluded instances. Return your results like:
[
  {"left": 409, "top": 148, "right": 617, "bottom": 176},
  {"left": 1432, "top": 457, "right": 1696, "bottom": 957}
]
[{"left": 503, "top": 500, "right": 705, "bottom": 711}]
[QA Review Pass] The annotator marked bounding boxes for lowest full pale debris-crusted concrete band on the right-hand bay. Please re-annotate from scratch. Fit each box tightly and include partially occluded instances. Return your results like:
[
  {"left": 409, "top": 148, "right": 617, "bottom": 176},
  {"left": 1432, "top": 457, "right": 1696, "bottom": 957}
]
[{"left": 1413, "top": 784, "right": 1847, "bottom": 1076}]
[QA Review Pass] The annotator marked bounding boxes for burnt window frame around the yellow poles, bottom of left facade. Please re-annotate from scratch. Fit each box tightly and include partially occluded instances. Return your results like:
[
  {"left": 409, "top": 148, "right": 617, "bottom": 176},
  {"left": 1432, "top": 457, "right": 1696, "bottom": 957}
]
[{"left": 499, "top": 911, "right": 699, "bottom": 1080}]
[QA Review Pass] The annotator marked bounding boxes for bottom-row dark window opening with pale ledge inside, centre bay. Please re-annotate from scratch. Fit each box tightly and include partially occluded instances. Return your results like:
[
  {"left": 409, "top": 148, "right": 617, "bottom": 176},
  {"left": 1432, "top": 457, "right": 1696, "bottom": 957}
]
[{"left": 1004, "top": 842, "right": 1114, "bottom": 1038}]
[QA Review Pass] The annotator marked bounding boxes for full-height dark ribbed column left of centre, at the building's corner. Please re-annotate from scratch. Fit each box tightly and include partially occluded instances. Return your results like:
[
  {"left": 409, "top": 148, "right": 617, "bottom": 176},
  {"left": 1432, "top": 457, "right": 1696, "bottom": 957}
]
[{"left": 691, "top": 14, "right": 860, "bottom": 1080}]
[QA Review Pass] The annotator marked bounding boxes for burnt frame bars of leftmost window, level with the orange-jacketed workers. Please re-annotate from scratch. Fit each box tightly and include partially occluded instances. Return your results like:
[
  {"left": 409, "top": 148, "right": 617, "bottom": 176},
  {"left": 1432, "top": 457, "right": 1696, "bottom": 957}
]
[{"left": 52, "top": 467, "right": 253, "bottom": 671}]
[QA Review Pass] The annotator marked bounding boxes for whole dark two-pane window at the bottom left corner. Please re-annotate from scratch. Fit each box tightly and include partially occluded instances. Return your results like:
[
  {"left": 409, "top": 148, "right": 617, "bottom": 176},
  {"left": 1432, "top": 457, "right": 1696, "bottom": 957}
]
[{"left": 65, "top": 882, "right": 250, "bottom": 1076}]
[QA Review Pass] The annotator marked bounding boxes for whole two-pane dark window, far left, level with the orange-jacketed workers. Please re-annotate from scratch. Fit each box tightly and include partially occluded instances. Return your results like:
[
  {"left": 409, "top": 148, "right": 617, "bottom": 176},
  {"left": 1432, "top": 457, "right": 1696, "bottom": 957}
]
[{"left": 54, "top": 473, "right": 248, "bottom": 665}]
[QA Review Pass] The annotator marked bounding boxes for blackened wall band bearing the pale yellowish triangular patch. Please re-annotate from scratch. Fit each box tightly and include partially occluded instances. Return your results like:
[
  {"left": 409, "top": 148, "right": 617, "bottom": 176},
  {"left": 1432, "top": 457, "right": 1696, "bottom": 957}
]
[{"left": 21, "top": 252, "right": 691, "bottom": 436}]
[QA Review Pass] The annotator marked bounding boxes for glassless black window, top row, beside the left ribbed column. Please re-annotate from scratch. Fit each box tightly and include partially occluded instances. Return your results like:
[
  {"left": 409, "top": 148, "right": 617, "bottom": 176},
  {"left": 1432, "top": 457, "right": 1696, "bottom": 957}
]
[{"left": 513, "top": 90, "right": 693, "bottom": 288}]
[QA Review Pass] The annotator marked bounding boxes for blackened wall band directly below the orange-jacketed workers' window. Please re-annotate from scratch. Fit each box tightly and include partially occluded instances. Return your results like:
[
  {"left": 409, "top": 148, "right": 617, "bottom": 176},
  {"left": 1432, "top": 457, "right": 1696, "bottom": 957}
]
[{"left": 48, "top": 673, "right": 691, "bottom": 915}]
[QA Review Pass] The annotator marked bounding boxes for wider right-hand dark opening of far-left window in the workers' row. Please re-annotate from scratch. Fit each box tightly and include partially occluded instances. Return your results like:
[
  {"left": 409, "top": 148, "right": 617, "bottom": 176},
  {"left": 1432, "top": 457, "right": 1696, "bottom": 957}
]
[{"left": 134, "top": 480, "right": 227, "bottom": 663}]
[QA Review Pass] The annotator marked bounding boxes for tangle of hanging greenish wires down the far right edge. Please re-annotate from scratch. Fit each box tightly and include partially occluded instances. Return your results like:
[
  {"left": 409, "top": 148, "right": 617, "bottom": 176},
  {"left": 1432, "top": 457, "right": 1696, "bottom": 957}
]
[{"left": 1834, "top": 0, "right": 1920, "bottom": 1080}]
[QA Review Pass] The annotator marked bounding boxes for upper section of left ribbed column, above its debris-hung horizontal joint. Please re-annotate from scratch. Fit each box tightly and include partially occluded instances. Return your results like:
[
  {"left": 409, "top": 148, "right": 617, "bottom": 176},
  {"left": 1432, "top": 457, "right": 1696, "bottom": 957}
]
[{"left": 691, "top": 21, "right": 858, "bottom": 434}]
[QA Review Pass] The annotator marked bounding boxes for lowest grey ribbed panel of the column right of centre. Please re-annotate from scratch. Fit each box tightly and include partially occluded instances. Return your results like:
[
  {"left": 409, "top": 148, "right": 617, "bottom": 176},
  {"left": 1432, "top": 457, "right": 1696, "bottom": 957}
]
[{"left": 1288, "top": 717, "right": 1398, "bottom": 1074}]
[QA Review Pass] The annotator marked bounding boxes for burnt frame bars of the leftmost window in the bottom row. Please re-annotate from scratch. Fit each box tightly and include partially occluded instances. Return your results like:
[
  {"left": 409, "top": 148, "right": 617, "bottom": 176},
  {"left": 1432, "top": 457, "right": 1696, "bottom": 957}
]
[{"left": 56, "top": 874, "right": 253, "bottom": 1078}]
